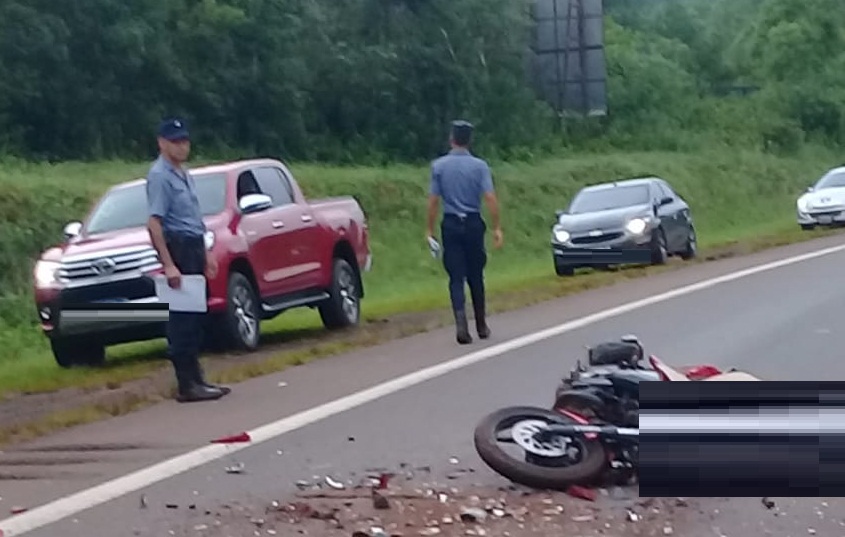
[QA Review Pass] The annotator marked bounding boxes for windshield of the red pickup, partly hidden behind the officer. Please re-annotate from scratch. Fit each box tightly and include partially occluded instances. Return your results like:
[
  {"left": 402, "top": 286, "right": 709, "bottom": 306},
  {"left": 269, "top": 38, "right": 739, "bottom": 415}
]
[{"left": 85, "top": 173, "right": 226, "bottom": 234}]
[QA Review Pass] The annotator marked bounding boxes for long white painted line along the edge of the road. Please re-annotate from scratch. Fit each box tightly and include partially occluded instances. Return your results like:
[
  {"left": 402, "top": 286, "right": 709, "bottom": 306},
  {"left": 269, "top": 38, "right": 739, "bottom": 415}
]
[{"left": 0, "top": 241, "right": 845, "bottom": 537}]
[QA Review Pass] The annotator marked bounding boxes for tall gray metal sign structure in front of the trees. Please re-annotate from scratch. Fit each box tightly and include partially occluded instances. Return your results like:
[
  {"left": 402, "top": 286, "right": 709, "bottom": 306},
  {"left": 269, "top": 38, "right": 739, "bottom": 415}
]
[{"left": 531, "top": 0, "right": 607, "bottom": 117}]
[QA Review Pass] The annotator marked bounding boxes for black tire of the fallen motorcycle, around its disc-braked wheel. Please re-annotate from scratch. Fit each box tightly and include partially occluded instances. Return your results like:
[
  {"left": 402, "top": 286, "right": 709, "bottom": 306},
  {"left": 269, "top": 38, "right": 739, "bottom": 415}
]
[{"left": 473, "top": 406, "right": 607, "bottom": 490}]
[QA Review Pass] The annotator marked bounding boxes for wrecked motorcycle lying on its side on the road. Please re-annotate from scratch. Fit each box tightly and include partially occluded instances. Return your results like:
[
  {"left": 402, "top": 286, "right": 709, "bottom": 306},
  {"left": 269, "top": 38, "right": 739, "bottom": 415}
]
[{"left": 474, "top": 336, "right": 759, "bottom": 489}]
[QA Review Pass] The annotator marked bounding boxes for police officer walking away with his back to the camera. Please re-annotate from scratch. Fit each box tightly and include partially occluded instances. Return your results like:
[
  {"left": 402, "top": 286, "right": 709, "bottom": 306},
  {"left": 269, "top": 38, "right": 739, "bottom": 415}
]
[{"left": 426, "top": 120, "right": 503, "bottom": 345}]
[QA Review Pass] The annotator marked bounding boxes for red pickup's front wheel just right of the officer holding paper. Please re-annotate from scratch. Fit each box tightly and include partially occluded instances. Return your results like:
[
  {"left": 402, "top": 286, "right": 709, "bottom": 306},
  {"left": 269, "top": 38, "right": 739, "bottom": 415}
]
[{"left": 222, "top": 272, "right": 260, "bottom": 351}]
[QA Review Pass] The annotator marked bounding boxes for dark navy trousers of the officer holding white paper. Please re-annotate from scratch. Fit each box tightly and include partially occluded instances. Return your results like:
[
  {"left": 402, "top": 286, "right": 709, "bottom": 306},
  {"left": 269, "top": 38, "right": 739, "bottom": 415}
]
[{"left": 165, "top": 230, "right": 206, "bottom": 391}]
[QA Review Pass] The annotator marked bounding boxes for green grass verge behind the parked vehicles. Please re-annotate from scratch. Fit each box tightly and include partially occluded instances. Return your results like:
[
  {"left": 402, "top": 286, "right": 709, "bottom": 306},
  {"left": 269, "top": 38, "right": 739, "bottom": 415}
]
[{"left": 0, "top": 147, "right": 838, "bottom": 395}]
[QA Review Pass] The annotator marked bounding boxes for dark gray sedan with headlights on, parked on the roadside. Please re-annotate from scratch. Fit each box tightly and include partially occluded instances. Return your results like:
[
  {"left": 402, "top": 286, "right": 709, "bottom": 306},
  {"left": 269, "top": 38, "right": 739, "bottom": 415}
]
[{"left": 552, "top": 177, "right": 697, "bottom": 276}]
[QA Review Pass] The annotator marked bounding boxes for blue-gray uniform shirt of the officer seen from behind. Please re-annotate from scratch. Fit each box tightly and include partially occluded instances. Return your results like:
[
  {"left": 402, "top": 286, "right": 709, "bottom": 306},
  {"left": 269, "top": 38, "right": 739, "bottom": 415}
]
[{"left": 429, "top": 149, "right": 493, "bottom": 216}]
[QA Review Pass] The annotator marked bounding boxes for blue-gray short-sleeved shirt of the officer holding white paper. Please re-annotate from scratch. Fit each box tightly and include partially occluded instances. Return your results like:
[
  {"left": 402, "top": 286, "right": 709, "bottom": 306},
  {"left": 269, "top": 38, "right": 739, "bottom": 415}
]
[{"left": 147, "top": 156, "right": 205, "bottom": 237}]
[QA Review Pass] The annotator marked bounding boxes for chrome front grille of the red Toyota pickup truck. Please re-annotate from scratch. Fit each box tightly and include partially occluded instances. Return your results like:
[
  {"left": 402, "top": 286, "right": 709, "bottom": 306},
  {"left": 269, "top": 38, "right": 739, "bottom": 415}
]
[{"left": 56, "top": 246, "right": 161, "bottom": 285}]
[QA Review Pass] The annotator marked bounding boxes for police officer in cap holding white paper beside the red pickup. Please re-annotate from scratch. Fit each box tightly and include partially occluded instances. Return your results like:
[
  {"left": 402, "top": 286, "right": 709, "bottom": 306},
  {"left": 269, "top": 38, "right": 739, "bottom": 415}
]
[{"left": 147, "top": 118, "right": 231, "bottom": 402}]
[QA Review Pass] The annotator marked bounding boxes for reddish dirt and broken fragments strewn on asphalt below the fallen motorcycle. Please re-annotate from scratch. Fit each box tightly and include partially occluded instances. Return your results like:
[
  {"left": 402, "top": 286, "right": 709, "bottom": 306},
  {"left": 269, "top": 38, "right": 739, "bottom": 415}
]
[{"left": 166, "top": 480, "right": 686, "bottom": 537}]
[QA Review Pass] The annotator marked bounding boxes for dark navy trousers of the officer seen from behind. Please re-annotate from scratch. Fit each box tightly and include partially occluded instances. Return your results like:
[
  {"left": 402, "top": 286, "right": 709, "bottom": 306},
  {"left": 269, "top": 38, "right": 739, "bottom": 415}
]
[{"left": 440, "top": 213, "right": 487, "bottom": 312}]
